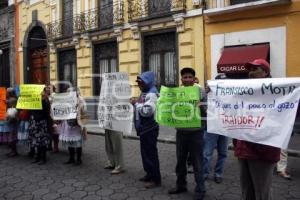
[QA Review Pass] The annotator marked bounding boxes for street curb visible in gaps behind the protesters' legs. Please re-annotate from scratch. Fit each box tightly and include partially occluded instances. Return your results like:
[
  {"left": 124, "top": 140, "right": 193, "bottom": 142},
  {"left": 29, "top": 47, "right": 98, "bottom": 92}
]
[{"left": 88, "top": 131, "right": 300, "bottom": 158}]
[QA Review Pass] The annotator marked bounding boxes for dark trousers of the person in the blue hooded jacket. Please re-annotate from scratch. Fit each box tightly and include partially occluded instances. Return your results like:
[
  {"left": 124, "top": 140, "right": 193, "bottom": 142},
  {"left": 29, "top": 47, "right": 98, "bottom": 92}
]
[{"left": 140, "top": 128, "right": 161, "bottom": 183}]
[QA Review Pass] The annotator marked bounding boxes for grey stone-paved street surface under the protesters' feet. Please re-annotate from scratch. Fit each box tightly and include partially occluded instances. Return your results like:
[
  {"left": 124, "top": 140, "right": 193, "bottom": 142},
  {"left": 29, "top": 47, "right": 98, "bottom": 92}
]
[{"left": 0, "top": 135, "right": 300, "bottom": 200}]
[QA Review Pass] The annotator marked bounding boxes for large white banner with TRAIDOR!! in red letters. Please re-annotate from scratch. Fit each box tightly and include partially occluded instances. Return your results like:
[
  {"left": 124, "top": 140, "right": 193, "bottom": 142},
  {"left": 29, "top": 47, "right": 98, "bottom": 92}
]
[{"left": 207, "top": 78, "right": 300, "bottom": 149}]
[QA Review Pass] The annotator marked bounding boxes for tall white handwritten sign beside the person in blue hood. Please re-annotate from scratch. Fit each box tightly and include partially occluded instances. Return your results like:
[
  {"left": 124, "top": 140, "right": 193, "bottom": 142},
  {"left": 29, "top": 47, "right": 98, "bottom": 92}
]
[{"left": 98, "top": 72, "right": 133, "bottom": 135}]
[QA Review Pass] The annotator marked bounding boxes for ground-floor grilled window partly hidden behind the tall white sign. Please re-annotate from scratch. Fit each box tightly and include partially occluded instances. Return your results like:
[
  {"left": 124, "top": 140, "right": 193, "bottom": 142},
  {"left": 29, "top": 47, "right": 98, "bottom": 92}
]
[{"left": 93, "top": 41, "right": 118, "bottom": 96}]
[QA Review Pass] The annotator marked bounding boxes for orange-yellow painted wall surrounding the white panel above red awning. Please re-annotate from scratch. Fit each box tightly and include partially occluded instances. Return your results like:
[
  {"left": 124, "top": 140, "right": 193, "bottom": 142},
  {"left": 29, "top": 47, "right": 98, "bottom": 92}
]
[{"left": 205, "top": 0, "right": 300, "bottom": 77}]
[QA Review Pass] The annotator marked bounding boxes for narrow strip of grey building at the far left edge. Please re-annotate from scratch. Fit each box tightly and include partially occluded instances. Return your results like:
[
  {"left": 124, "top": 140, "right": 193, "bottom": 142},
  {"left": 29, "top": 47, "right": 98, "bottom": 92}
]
[{"left": 0, "top": 1, "right": 16, "bottom": 87}]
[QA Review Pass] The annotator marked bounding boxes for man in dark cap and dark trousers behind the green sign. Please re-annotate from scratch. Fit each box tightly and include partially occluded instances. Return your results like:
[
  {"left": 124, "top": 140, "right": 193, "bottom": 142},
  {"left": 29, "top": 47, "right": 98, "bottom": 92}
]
[{"left": 169, "top": 68, "right": 206, "bottom": 200}]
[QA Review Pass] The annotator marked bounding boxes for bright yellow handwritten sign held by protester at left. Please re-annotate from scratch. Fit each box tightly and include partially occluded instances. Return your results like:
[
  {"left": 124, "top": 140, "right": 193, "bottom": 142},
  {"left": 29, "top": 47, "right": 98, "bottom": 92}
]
[{"left": 17, "top": 84, "right": 45, "bottom": 110}]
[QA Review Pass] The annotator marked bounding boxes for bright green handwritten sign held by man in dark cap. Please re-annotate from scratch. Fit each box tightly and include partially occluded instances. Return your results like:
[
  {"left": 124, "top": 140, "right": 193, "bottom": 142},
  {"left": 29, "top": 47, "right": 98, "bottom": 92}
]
[{"left": 155, "top": 86, "right": 201, "bottom": 128}]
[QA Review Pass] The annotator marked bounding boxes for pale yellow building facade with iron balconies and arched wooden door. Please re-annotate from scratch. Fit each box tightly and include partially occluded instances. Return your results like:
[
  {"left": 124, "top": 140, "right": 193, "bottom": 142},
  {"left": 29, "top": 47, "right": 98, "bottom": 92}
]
[{"left": 17, "top": 0, "right": 205, "bottom": 120}]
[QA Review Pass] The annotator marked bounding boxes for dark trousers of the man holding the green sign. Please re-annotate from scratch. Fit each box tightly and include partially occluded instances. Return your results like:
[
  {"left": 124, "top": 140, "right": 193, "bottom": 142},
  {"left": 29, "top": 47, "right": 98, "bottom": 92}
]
[{"left": 176, "top": 130, "right": 205, "bottom": 193}]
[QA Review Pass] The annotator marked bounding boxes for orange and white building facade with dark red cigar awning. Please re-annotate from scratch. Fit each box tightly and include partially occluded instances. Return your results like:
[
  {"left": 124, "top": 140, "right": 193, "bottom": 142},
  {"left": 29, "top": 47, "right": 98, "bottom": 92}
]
[{"left": 204, "top": 0, "right": 300, "bottom": 79}]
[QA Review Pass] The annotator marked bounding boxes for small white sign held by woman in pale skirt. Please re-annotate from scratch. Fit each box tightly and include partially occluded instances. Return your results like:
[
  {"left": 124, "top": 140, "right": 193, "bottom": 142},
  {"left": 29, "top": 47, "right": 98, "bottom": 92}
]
[{"left": 51, "top": 92, "right": 78, "bottom": 120}]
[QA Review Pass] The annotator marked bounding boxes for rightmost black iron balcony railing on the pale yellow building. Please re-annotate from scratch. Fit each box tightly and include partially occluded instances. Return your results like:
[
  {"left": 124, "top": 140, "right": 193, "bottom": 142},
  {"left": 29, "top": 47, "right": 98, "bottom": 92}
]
[{"left": 128, "top": 0, "right": 186, "bottom": 22}]
